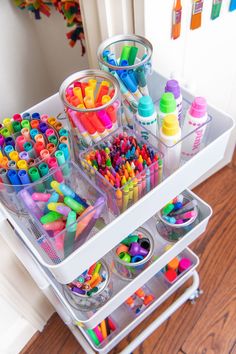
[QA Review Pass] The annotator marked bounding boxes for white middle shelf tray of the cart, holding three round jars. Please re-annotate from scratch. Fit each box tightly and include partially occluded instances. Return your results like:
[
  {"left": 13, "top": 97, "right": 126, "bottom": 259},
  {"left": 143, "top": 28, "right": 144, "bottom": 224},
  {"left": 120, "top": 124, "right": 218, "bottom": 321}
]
[{"left": 34, "top": 191, "right": 212, "bottom": 328}]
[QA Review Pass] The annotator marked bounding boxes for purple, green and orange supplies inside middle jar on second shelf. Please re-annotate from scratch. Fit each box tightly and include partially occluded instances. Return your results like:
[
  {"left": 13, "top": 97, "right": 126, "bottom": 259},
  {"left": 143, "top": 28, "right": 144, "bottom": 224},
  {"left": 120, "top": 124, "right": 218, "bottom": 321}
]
[{"left": 116, "top": 232, "right": 151, "bottom": 263}]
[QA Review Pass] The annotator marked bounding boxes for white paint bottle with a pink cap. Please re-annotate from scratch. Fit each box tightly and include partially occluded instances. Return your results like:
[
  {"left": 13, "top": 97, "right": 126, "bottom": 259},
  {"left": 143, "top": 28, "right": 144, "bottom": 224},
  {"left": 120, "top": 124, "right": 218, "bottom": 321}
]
[{"left": 182, "top": 97, "right": 208, "bottom": 159}]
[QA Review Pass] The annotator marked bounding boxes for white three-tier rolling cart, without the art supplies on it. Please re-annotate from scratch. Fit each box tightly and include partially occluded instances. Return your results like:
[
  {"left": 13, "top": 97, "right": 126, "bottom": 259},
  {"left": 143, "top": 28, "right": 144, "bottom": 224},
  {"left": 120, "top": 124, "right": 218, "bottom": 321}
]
[{"left": 0, "top": 70, "right": 234, "bottom": 354}]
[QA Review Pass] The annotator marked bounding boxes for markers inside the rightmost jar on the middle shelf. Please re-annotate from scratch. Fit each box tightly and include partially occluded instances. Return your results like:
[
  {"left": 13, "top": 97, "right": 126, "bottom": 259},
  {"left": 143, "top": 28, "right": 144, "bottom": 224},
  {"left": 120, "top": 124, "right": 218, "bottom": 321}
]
[{"left": 161, "top": 194, "right": 197, "bottom": 226}]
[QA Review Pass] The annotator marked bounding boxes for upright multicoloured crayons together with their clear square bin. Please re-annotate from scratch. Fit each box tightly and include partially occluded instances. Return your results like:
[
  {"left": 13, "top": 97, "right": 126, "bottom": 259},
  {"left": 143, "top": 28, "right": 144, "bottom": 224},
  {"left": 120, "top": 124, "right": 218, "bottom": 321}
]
[{"left": 80, "top": 127, "right": 163, "bottom": 215}]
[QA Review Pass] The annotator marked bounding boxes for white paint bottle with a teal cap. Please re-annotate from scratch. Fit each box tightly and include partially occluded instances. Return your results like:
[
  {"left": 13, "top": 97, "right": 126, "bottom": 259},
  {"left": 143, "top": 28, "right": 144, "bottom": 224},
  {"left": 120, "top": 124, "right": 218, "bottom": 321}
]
[{"left": 136, "top": 96, "right": 157, "bottom": 145}]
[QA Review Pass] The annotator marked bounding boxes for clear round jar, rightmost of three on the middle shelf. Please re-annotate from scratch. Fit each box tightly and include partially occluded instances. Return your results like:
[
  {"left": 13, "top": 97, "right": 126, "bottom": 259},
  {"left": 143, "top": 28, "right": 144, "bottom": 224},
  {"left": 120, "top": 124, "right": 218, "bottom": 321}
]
[{"left": 156, "top": 193, "right": 199, "bottom": 242}]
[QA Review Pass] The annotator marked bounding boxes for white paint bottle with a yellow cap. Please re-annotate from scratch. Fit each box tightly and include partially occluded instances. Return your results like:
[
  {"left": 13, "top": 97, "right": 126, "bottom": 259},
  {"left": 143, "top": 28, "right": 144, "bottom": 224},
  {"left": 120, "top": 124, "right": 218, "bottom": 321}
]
[{"left": 160, "top": 114, "right": 181, "bottom": 177}]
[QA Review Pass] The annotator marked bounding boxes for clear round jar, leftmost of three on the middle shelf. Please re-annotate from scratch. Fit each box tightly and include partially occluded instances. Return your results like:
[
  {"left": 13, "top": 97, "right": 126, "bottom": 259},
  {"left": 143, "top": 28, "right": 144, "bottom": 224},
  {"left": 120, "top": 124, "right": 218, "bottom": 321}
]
[{"left": 64, "top": 260, "right": 113, "bottom": 312}]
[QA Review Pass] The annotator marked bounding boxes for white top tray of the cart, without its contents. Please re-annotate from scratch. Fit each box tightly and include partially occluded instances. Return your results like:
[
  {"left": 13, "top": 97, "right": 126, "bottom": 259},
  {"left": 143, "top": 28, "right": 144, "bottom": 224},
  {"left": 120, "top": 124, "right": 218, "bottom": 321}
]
[{"left": 2, "top": 73, "right": 234, "bottom": 284}]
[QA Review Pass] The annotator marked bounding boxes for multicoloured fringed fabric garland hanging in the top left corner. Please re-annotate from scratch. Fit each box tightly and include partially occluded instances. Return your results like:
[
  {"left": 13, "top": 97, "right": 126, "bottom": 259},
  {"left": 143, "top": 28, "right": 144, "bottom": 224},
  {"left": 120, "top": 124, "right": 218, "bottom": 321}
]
[{"left": 14, "top": 0, "right": 85, "bottom": 55}]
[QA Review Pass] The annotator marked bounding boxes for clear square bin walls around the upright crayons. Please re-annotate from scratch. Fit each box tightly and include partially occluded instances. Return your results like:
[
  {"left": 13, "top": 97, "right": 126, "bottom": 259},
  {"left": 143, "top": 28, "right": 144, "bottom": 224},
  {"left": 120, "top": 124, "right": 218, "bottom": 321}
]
[{"left": 80, "top": 127, "right": 163, "bottom": 215}]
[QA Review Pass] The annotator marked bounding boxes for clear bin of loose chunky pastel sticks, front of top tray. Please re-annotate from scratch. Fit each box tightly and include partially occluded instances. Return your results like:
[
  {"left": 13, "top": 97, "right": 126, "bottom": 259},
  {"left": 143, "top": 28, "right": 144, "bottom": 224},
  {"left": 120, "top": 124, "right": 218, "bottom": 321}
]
[{"left": 18, "top": 162, "right": 110, "bottom": 264}]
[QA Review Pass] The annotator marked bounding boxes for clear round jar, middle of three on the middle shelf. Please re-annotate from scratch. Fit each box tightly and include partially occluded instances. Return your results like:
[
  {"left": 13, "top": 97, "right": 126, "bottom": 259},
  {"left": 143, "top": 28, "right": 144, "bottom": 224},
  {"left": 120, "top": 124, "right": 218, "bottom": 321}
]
[{"left": 113, "top": 227, "right": 154, "bottom": 280}]
